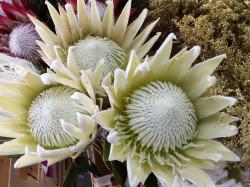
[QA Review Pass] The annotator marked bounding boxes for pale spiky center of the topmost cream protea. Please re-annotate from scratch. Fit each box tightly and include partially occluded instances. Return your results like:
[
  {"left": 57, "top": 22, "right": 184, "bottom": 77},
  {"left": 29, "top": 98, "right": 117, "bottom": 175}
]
[{"left": 74, "top": 36, "right": 126, "bottom": 76}]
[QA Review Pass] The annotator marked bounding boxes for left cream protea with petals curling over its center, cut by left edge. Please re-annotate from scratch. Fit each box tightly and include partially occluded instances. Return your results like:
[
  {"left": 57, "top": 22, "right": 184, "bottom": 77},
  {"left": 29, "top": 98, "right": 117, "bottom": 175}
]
[{"left": 0, "top": 55, "right": 99, "bottom": 168}]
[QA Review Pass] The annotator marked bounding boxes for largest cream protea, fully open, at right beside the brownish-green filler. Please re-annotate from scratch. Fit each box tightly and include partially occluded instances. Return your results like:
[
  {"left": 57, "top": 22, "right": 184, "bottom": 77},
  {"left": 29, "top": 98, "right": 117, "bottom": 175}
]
[{"left": 94, "top": 34, "right": 239, "bottom": 187}]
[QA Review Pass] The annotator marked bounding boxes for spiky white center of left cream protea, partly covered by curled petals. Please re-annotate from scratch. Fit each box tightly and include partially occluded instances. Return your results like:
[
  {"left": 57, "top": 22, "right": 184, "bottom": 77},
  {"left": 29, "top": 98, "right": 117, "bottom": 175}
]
[{"left": 28, "top": 86, "right": 81, "bottom": 149}]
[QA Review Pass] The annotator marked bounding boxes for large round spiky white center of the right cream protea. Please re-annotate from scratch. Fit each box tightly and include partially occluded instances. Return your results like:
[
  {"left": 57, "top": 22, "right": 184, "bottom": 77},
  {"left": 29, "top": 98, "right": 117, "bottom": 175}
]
[{"left": 119, "top": 81, "right": 197, "bottom": 152}]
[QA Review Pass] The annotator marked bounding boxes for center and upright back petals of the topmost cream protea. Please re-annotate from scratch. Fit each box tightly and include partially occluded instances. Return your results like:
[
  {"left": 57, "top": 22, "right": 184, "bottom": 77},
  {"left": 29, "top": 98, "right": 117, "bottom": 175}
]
[{"left": 31, "top": 0, "right": 160, "bottom": 76}]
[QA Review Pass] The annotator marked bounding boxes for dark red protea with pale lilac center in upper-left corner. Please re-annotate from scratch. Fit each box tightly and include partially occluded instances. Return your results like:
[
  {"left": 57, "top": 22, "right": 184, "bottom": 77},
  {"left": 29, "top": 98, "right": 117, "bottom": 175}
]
[{"left": 0, "top": 0, "right": 40, "bottom": 60}]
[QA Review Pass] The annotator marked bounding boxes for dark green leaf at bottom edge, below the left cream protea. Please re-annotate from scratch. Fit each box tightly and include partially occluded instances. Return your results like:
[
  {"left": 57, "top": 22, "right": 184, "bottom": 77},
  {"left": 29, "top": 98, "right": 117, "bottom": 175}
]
[{"left": 62, "top": 163, "right": 80, "bottom": 187}]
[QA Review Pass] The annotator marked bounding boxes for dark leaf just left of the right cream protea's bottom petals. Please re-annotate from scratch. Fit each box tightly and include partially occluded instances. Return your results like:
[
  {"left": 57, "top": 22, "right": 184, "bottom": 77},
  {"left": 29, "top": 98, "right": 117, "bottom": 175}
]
[{"left": 111, "top": 161, "right": 127, "bottom": 185}]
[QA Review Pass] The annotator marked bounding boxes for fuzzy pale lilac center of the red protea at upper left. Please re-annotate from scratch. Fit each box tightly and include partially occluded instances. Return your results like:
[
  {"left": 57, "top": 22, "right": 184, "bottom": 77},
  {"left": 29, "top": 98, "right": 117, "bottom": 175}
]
[{"left": 9, "top": 24, "right": 40, "bottom": 59}]
